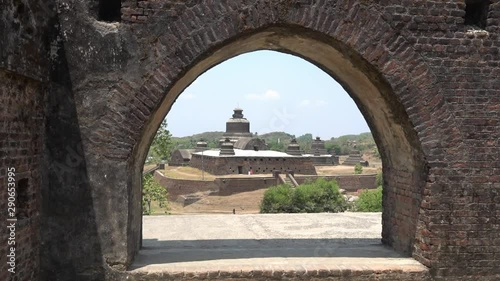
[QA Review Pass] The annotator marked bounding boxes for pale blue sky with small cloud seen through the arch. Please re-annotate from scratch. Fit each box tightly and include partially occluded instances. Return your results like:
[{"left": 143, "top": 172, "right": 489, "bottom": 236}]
[{"left": 166, "top": 51, "right": 370, "bottom": 139}]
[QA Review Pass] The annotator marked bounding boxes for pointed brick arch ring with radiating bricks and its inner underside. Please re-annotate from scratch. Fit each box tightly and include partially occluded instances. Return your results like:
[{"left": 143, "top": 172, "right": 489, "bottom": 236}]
[{"left": 96, "top": 1, "right": 457, "bottom": 270}]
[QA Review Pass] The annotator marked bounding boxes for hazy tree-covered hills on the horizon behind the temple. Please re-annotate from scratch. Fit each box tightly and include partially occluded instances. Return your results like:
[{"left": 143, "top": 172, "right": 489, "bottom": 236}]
[{"left": 172, "top": 132, "right": 378, "bottom": 157}]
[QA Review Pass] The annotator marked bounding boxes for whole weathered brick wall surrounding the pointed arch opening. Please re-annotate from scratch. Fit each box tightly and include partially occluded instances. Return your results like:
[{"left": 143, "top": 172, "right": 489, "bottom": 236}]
[{"left": 0, "top": 0, "right": 500, "bottom": 280}]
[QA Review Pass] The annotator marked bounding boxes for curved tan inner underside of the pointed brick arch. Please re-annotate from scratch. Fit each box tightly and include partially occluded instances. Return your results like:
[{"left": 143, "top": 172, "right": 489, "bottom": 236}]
[{"left": 130, "top": 27, "right": 426, "bottom": 266}]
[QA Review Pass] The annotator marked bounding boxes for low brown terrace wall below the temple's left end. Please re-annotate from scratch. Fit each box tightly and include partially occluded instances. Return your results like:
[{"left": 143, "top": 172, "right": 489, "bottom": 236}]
[{"left": 154, "top": 171, "right": 218, "bottom": 201}]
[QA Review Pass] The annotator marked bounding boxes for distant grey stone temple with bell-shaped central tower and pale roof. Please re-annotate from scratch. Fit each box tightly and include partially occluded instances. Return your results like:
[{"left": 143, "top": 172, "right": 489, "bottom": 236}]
[{"left": 170, "top": 108, "right": 338, "bottom": 175}]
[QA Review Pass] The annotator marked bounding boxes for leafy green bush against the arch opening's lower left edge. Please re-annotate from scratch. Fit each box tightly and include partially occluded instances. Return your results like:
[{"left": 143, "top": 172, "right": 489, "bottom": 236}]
[{"left": 142, "top": 174, "right": 168, "bottom": 215}]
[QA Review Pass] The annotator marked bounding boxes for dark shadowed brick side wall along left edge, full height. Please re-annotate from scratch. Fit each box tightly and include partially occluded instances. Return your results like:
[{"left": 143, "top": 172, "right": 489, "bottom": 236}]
[{"left": 0, "top": 0, "right": 56, "bottom": 281}]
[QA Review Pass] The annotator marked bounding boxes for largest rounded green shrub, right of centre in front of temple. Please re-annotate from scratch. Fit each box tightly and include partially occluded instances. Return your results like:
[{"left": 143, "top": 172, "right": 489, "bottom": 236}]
[{"left": 260, "top": 179, "right": 348, "bottom": 213}]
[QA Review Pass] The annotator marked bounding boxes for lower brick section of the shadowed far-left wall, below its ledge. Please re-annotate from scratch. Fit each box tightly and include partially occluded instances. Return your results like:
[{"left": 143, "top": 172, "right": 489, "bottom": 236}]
[{"left": 0, "top": 70, "right": 45, "bottom": 281}]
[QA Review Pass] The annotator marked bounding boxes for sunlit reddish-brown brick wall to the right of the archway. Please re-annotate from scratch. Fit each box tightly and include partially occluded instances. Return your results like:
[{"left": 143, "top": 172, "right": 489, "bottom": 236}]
[{"left": 382, "top": 0, "right": 500, "bottom": 274}]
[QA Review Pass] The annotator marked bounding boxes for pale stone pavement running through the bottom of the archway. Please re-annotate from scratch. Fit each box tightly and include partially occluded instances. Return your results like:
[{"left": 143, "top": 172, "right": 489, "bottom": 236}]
[{"left": 127, "top": 213, "right": 428, "bottom": 280}]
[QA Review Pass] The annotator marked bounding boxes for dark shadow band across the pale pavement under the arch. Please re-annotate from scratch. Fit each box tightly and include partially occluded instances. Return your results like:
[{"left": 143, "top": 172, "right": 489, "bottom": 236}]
[{"left": 131, "top": 238, "right": 403, "bottom": 269}]
